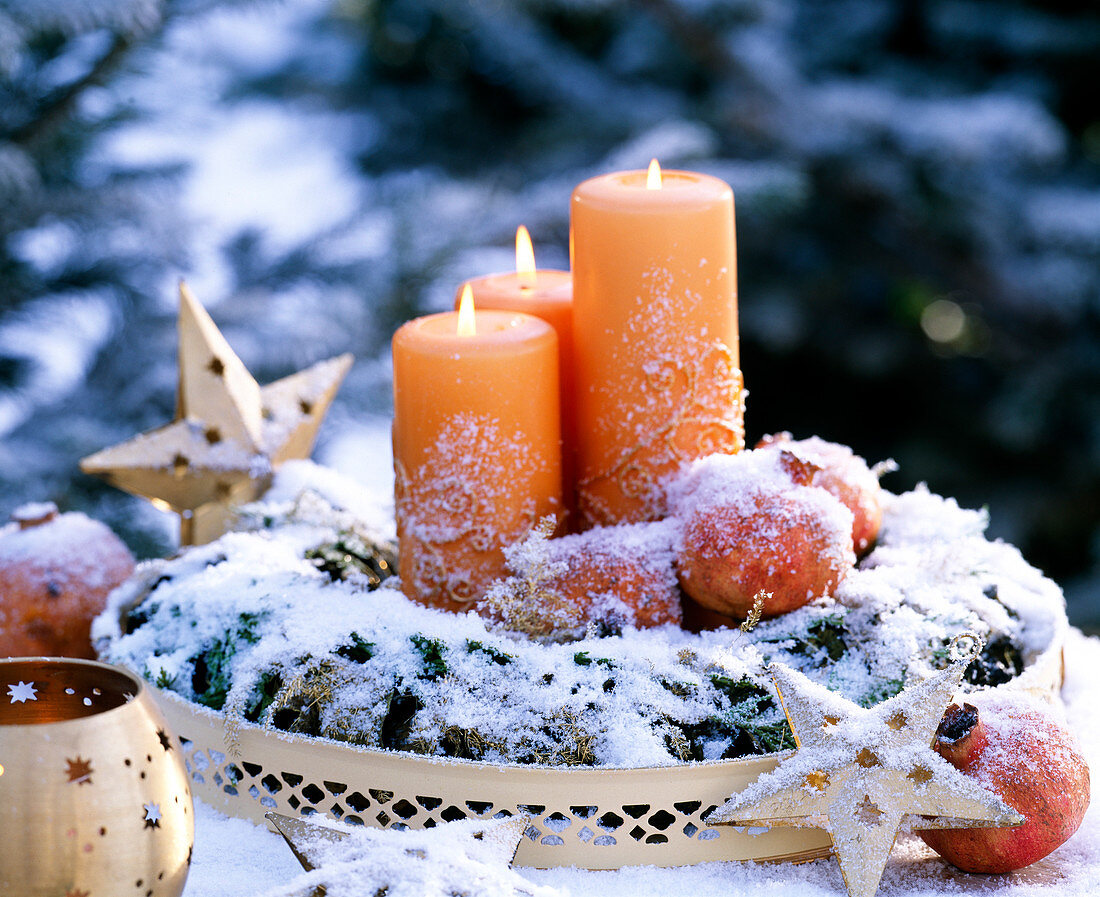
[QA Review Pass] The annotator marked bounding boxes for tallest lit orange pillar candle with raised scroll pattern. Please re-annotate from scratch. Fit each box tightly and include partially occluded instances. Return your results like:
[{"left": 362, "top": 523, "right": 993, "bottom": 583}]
[{"left": 571, "top": 161, "right": 745, "bottom": 526}]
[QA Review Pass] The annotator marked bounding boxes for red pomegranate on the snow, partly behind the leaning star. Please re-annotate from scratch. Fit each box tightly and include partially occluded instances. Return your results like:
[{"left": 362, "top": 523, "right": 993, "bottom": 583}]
[{"left": 920, "top": 703, "right": 1089, "bottom": 873}]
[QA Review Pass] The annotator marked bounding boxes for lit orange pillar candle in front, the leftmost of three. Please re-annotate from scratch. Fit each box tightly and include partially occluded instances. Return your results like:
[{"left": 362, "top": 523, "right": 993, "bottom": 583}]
[{"left": 393, "top": 290, "right": 561, "bottom": 611}]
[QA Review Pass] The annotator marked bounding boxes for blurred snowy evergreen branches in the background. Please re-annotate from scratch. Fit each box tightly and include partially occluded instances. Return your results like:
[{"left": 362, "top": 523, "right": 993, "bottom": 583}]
[{"left": 0, "top": 0, "right": 1100, "bottom": 631}]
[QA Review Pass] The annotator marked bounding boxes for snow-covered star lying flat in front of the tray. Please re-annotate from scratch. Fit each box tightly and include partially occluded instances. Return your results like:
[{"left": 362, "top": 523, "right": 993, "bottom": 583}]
[{"left": 267, "top": 813, "right": 563, "bottom": 897}]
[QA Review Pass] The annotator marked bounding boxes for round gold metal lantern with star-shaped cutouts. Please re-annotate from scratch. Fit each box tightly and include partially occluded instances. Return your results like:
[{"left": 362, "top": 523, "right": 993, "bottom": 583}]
[{"left": 0, "top": 657, "right": 195, "bottom": 897}]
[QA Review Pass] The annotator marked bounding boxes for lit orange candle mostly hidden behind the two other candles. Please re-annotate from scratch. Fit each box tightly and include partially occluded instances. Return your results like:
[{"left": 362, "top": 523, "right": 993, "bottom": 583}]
[{"left": 454, "top": 225, "right": 576, "bottom": 523}]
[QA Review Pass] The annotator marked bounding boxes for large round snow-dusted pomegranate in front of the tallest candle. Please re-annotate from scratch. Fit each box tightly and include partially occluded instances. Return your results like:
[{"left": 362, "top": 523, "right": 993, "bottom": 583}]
[{"left": 675, "top": 451, "right": 856, "bottom": 619}]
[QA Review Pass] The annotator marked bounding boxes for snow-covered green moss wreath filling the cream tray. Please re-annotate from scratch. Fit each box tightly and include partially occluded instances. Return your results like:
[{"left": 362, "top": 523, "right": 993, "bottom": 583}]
[{"left": 94, "top": 463, "right": 1063, "bottom": 767}]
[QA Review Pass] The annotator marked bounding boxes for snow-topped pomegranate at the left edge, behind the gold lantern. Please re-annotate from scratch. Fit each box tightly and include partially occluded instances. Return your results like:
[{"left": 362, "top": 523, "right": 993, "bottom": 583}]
[{"left": 0, "top": 502, "right": 134, "bottom": 657}]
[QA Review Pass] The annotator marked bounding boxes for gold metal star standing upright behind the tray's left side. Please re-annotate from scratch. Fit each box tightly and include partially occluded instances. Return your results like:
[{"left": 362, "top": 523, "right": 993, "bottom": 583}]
[{"left": 80, "top": 282, "right": 352, "bottom": 545}]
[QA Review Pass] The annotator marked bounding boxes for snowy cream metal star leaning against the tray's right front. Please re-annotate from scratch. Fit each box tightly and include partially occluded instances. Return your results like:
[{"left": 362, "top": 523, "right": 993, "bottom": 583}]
[{"left": 706, "top": 636, "right": 1023, "bottom": 897}]
